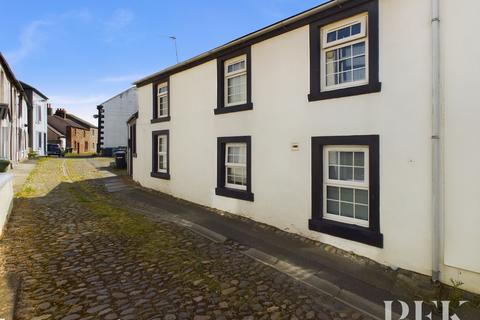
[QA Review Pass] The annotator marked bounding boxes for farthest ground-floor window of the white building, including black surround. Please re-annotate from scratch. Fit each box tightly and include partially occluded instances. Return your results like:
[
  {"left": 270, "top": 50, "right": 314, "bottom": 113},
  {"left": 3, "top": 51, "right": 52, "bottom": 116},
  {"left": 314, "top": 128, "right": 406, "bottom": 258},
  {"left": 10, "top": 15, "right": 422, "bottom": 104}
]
[{"left": 151, "top": 130, "right": 170, "bottom": 179}]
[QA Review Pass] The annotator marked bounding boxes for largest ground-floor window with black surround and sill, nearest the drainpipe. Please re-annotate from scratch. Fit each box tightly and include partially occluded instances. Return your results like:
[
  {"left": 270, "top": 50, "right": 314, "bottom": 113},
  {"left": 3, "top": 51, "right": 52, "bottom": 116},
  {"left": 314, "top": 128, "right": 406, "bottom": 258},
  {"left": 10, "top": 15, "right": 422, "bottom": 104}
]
[{"left": 309, "top": 135, "right": 383, "bottom": 247}]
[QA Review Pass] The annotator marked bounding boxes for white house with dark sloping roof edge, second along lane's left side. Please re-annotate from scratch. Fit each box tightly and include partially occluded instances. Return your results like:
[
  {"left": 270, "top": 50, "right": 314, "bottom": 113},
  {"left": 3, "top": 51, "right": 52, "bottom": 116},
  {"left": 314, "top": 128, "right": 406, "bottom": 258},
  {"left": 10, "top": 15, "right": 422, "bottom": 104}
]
[{"left": 20, "top": 82, "right": 49, "bottom": 156}]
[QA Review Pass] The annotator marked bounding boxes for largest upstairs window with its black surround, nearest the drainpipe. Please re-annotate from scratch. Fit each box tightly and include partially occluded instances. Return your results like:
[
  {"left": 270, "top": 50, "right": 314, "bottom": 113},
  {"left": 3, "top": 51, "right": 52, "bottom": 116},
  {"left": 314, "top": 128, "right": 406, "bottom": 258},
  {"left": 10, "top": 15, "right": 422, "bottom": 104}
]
[{"left": 308, "top": 0, "right": 382, "bottom": 101}]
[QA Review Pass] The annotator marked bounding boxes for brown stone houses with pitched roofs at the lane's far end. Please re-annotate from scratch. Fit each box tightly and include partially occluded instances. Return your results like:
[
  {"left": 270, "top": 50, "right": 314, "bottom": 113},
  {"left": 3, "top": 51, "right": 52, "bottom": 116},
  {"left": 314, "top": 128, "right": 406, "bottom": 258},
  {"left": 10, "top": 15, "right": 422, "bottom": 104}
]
[{"left": 48, "top": 108, "right": 97, "bottom": 153}]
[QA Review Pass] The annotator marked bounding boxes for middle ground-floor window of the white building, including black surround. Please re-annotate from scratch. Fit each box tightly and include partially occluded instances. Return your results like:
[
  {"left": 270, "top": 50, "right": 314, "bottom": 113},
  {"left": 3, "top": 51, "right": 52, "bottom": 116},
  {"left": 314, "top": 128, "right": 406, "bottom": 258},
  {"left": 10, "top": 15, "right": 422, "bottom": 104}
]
[{"left": 215, "top": 136, "right": 253, "bottom": 201}]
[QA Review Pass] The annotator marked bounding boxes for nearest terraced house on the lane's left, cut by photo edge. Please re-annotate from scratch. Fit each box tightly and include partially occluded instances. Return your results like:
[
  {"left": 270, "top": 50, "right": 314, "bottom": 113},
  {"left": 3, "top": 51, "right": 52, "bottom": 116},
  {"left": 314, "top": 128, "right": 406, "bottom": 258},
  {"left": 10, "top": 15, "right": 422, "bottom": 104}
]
[{"left": 0, "top": 53, "right": 30, "bottom": 166}]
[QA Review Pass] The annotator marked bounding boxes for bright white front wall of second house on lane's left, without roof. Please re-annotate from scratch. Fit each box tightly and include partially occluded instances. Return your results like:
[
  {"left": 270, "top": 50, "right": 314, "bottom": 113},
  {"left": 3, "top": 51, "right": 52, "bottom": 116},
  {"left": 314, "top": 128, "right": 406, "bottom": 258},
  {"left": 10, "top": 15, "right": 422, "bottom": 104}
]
[{"left": 30, "top": 91, "right": 48, "bottom": 156}]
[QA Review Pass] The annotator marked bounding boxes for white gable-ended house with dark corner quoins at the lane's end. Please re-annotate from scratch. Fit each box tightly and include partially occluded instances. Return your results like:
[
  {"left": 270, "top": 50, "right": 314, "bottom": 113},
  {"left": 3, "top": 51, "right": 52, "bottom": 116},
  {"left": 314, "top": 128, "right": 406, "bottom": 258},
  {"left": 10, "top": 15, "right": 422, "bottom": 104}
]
[{"left": 95, "top": 87, "right": 138, "bottom": 155}]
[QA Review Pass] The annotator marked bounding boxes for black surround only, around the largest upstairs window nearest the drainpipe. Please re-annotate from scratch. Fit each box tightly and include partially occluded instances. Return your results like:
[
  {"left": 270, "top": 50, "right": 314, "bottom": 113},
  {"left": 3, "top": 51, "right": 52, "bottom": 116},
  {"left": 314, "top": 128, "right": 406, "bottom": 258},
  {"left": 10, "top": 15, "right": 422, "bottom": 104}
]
[{"left": 308, "top": 0, "right": 382, "bottom": 101}]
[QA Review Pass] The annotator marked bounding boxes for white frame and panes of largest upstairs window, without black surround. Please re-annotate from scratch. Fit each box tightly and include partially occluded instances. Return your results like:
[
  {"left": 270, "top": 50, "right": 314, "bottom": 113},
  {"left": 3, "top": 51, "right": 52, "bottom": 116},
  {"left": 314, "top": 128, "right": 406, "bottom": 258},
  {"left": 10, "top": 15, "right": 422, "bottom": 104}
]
[{"left": 321, "top": 14, "right": 368, "bottom": 90}]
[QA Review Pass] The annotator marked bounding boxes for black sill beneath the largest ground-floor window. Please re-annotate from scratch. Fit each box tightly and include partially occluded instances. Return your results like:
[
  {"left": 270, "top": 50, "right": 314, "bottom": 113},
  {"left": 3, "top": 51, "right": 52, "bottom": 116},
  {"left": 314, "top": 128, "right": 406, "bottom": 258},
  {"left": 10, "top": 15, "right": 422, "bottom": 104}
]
[{"left": 308, "top": 219, "right": 383, "bottom": 248}]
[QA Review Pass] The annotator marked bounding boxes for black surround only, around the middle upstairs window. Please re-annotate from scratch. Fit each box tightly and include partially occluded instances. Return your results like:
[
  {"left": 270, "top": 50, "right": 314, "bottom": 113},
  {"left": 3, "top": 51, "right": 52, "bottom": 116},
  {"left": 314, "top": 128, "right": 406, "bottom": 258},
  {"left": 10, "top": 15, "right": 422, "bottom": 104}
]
[{"left": 213, "top": 46, "right": 253, "bottom": 114}]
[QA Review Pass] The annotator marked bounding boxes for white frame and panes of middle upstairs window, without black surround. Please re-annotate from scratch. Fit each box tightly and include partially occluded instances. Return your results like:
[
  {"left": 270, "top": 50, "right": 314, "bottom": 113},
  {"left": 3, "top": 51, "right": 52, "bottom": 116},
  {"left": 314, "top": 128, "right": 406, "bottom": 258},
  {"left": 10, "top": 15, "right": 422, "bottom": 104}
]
[{"left": 225, "top": 55, "right": 247, "bottom": 107}]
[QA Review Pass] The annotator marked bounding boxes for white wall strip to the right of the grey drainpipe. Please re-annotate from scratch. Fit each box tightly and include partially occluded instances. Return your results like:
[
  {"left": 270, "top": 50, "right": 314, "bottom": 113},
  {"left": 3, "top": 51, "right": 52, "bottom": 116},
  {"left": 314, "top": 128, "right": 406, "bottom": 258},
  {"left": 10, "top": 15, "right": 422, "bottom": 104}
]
[{"left": 441, "top": 0, "right": 480, "bottom": 290}]
